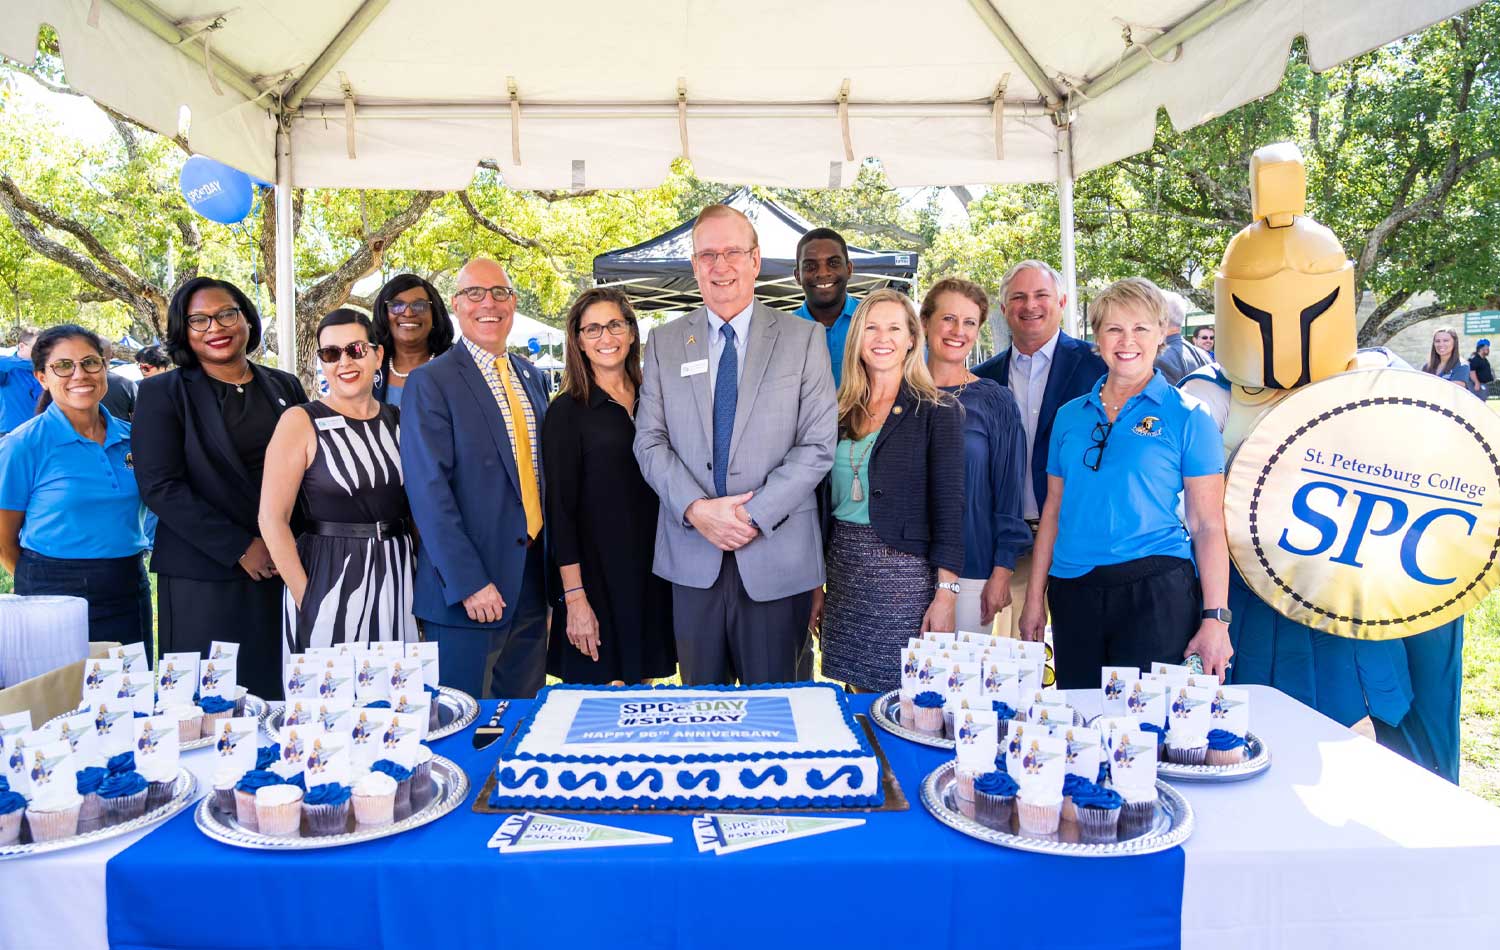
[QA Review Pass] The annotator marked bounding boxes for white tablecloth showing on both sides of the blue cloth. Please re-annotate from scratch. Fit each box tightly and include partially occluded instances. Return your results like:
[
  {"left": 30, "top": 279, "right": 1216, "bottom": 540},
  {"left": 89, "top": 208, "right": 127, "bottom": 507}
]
[{"left": 0, "top": 686, "right": 1500, "bottom": 950}]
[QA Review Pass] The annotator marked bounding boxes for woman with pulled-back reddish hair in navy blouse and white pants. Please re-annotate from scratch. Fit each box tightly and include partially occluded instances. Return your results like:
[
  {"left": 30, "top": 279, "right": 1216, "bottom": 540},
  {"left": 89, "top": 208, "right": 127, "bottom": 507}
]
[{"left": 921, "top": 278, "right": 1032, "bottom": 632}]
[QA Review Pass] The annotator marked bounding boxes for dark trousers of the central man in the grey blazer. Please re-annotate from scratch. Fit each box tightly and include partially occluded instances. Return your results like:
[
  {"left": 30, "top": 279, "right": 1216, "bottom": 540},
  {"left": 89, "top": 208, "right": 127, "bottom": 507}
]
[{"left": 672, "top": 554, "right": 813, "bottom": 686}]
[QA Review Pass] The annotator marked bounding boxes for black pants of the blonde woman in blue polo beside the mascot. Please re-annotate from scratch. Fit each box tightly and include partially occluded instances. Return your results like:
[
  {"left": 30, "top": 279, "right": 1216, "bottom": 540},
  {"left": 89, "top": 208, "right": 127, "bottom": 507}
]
[{"left": 1047, "top": 557, "right": 1203, "bottom": 689}]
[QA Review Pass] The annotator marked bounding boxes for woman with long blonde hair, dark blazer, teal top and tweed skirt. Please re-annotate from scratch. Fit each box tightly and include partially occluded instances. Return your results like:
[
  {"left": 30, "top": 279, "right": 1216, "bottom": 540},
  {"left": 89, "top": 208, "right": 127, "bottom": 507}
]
[{"left": 815, "top": 290, "right": 965, "bottom": 690}]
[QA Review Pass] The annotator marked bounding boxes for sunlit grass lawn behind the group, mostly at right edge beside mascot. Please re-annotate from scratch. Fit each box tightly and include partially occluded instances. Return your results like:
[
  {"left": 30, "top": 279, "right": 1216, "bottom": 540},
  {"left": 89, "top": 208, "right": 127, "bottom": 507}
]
[{"left": 0, "top": 570, "right": 1500, "bottom": 804}]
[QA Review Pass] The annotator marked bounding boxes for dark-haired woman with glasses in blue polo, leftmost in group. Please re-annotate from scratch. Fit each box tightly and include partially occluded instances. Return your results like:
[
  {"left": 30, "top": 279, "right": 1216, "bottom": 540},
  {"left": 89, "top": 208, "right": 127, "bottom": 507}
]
[{"left": 0, "top": 324, "right": 152, "bottom": 644}]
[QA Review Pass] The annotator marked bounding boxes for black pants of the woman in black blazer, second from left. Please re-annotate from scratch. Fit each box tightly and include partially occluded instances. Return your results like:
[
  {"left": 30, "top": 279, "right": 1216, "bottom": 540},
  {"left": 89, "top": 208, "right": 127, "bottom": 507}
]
[{"left": 156, "top": 573, "right": 287, "bottom": 699}]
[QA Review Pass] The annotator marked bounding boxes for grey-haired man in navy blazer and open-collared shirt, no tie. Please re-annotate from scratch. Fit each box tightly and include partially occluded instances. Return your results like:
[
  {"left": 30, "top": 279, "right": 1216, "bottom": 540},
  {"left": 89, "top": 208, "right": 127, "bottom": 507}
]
[{"left": 974, "top": 261, "right": 1106, "bottom": 636}]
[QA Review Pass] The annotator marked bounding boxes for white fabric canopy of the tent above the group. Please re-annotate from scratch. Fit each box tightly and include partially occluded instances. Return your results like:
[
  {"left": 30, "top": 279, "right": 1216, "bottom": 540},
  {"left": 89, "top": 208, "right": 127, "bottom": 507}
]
[{"left": 0, "top": 0, "right": 1472, "bottom": 189}]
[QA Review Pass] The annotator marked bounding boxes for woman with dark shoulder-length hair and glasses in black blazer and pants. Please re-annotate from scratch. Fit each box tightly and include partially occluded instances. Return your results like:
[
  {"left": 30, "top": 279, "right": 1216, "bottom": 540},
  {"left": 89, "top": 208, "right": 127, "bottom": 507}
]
[{"left": 132, "top": 278, "right": 308, "bottom": 699}]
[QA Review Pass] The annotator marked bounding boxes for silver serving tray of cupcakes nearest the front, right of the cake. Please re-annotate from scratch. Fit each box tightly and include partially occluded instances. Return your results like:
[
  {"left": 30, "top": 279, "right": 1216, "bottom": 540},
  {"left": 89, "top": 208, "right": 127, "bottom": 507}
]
[{"left": 923, "top": 762, "right": 1194, "bottom": 857}]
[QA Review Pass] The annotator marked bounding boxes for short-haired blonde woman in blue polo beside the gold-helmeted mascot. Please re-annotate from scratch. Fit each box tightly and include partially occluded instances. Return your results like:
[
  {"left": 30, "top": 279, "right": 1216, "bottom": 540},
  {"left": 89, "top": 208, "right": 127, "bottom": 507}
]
[{"left": 1020, "top": 278, "right": 1233, "bottom": 689}]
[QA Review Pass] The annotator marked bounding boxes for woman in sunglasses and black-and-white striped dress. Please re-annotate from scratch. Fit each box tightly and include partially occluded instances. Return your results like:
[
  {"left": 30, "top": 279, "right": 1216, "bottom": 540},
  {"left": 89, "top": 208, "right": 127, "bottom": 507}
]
[{"left": 261, "top": 309, "right": 417, "bottom": 653}]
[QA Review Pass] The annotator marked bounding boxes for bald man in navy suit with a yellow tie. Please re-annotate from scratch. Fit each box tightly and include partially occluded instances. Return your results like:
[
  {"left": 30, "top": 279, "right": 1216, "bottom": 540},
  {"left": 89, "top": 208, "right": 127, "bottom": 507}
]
[{"left": 401, "top": 260, "right": 548, "bottom": 698}]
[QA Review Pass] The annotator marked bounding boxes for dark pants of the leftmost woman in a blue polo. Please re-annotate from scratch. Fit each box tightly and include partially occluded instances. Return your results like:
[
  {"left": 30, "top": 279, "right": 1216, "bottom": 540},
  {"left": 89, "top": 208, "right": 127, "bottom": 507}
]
[{"left": 15, "top": 548, "right": 152, "bottom": 644}]
